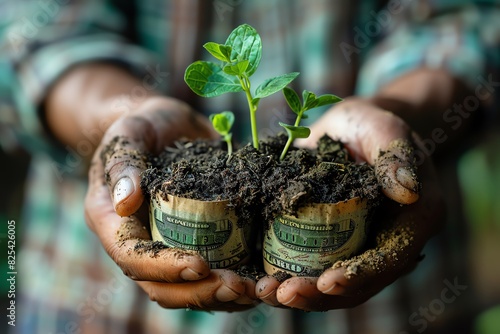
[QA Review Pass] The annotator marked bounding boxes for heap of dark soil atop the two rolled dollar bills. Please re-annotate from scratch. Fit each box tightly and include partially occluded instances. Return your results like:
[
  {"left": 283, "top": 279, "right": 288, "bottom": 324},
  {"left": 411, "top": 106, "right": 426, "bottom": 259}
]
[{"left": 141, "top": 134, "right": 380, "bottom": 223}]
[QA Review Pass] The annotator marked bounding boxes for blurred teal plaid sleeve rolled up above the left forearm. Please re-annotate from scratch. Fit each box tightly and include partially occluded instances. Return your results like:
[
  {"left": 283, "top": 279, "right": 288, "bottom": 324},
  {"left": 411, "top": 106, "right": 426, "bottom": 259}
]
[{"left": 0, "top": 0, "right": 158, "bottom": 160}]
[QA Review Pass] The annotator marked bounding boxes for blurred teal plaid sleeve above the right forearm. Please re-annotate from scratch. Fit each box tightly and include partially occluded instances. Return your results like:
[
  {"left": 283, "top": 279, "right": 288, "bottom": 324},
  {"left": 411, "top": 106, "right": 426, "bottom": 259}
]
[{"left": 357, "top": 0, "right": 500, "bottom": 95}]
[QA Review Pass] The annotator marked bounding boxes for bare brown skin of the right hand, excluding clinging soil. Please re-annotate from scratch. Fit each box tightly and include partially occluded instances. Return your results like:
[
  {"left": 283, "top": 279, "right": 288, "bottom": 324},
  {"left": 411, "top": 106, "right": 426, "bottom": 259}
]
[{"left": 257, "top": 99, "right": 444, "bottom": 311}]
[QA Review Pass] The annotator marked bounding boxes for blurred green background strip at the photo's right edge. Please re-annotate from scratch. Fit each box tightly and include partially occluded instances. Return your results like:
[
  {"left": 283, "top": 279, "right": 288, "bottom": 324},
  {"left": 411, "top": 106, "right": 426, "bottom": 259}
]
[{"left": 458, "top": 133, "right": 500, "bottom": 334}]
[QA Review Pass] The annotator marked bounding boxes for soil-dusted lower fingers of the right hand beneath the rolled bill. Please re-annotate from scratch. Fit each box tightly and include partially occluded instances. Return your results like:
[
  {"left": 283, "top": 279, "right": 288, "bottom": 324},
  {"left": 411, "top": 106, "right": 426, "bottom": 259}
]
[{"left": 257, "top": 215, "right": 424, "bottom": 311}]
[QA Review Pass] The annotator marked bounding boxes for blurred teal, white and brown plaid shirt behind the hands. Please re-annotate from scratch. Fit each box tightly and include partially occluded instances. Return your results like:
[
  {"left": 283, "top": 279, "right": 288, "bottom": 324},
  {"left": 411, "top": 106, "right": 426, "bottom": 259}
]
[{"left": 0, "top": 0, "right": 500, "bottom": 334}]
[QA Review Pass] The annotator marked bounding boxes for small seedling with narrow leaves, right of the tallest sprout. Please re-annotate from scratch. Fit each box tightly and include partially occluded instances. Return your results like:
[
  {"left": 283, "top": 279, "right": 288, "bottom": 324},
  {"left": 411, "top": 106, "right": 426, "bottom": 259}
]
[{"left": 279, "top": 87, "right": 342, "bottom": 160}]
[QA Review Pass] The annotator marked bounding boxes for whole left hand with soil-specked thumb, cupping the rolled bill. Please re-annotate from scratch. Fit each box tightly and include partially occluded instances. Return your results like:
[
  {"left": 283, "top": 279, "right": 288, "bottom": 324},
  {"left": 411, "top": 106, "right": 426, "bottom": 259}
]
[{"left": 85, "top": 97, "right": 255, "bottom": 311}]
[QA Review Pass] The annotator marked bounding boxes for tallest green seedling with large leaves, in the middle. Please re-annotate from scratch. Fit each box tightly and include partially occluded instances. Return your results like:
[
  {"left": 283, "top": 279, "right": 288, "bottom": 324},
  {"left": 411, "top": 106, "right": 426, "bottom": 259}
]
[{"left": 184, "top": 24, "right": 299, "bottom": 149}]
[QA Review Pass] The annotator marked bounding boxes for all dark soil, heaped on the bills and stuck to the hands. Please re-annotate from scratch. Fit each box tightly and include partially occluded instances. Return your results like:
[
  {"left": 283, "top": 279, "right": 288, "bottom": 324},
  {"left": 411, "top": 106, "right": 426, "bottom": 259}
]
[{"left": 101, "top": 135, "right": 418, "bottom": 282}]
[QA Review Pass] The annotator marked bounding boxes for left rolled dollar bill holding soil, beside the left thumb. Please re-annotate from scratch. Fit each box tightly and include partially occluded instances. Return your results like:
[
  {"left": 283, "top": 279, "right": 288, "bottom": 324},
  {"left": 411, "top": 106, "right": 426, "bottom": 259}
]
[{"left": 149, "top": 192, "right": 251, "bottom": 269}]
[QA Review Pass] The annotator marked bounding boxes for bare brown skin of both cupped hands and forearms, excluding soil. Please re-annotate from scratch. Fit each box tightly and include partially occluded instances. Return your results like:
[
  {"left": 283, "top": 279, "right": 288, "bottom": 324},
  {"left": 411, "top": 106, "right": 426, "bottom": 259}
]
[{"left": 45, "top": 64, "right": 464, "bottom": 311}]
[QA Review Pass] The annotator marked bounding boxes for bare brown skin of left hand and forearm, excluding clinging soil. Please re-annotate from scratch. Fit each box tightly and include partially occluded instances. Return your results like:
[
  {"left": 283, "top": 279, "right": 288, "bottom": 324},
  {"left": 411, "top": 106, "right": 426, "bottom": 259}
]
[{"left": 45, "top": 64, "right": 255, "bottom": 310}]
